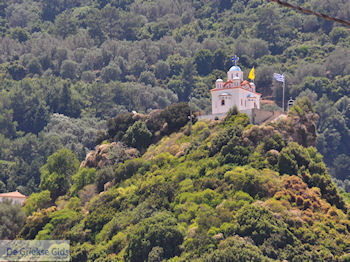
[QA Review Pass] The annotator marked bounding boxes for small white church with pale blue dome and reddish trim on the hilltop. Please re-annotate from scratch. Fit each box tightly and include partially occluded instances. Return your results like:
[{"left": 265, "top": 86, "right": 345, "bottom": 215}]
[{"left": 210, "top": 62, "right": 261, "bottom": 115}]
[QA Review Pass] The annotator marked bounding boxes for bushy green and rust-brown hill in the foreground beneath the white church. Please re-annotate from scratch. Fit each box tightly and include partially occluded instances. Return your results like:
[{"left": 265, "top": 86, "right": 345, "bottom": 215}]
[{"left": 19, "top": 99, "right": 350, "bottom": 261}]
